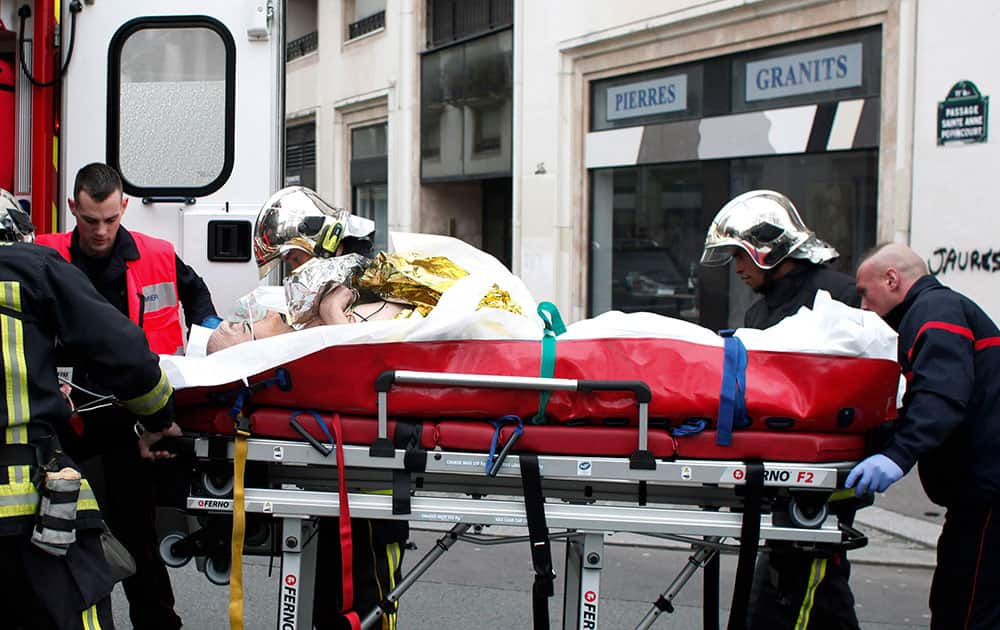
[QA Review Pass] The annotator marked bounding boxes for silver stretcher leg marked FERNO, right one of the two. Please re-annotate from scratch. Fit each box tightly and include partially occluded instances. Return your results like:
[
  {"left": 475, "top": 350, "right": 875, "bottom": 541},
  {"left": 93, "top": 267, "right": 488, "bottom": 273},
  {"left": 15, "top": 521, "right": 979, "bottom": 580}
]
[{"left": 563, "top": 534, "right": 604, "bottom": 630}]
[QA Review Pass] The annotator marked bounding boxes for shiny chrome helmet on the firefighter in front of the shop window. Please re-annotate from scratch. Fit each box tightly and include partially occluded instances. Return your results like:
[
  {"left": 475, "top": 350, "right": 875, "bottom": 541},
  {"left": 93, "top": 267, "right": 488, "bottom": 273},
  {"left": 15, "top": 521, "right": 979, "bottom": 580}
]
[{"left": 701, "top": 190, "right": 840, "bottom": 270}]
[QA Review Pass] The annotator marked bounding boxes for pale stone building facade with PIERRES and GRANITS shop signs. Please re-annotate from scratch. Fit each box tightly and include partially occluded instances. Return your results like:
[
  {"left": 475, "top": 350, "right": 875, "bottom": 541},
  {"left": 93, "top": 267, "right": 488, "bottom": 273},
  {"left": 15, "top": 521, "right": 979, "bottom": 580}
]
[{"left": 287, "top": 0, "right": 1000, "bottom": 328}]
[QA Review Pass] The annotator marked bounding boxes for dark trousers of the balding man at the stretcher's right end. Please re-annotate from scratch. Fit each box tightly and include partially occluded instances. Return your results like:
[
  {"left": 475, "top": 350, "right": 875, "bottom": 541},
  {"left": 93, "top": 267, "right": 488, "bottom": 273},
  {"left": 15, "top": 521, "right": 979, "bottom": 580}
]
[{"left": 930, "top": 502, "right": 1000, "bottom": 630}]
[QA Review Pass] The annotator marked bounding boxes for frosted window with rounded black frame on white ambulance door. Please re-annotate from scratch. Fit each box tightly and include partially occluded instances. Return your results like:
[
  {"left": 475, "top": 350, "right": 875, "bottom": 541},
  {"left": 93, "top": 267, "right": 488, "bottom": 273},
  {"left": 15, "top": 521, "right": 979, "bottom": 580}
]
[{"left": 107, "top": 17, "right": 236, "bottom": 197}]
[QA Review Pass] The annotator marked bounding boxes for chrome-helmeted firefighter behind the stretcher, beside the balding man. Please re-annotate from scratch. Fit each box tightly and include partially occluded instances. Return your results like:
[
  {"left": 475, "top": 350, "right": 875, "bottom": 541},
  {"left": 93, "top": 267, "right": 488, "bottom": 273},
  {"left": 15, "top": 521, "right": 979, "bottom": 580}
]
[{"left": 701, "top": 190, "right": 860, "bottom": 630}]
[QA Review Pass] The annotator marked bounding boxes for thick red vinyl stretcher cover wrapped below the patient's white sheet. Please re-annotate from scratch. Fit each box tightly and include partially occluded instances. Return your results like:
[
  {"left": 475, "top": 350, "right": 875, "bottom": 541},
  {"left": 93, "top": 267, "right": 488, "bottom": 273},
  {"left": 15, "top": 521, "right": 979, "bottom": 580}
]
[{"left": 178, "top": 338, "right": 899, "bottom": 434}]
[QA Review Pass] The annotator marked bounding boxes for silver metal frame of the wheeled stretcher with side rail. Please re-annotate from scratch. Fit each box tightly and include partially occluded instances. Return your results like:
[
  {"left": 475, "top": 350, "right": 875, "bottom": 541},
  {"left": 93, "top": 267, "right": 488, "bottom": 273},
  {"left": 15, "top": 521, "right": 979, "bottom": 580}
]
[{"left": 172, "top": 372, "right": 866, "bottom": 630}]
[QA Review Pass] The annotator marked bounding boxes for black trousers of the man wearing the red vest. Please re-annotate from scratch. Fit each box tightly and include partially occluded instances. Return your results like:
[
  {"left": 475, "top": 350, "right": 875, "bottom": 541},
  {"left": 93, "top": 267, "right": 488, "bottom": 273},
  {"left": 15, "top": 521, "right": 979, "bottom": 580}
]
[{"left": 63, "top": 410, "right": 182, "bottom": 630}]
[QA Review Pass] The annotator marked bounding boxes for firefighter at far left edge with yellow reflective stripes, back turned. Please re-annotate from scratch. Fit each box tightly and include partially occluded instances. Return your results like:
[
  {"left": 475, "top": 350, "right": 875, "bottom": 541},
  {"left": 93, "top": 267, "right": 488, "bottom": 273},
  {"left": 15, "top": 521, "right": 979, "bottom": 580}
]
[{"left": 0, "top": 191, "right": 180, "bottom": 630}]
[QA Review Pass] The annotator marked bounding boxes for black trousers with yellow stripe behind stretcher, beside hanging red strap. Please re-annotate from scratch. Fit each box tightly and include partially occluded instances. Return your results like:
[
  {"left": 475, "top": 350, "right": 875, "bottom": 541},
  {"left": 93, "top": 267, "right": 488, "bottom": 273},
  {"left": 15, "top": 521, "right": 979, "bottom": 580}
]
[{"left": 313, "top": 518, "right": 409, "bottom": 630}]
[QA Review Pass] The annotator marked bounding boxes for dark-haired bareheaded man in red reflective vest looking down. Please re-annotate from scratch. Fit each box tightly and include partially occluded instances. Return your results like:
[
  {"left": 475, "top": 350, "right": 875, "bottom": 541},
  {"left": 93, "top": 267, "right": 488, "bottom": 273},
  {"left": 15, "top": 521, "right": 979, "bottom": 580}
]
[{"left": 37, "top": 163, "right": 219, "bottom": 630}]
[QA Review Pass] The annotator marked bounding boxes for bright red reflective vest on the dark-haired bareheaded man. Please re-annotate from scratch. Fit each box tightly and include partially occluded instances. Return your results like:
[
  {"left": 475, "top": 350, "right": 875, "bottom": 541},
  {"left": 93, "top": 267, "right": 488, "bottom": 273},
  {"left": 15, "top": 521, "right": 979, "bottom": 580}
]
[{"left": 35, "top": 231, "right": 184, "bottom": 354}]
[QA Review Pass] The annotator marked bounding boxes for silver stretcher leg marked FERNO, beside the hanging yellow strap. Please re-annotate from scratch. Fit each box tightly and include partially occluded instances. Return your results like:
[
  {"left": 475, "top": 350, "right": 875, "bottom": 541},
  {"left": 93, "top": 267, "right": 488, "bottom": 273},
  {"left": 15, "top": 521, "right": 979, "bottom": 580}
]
[{"left": 276, "top": 517, "right": 317, "bottom": 630}]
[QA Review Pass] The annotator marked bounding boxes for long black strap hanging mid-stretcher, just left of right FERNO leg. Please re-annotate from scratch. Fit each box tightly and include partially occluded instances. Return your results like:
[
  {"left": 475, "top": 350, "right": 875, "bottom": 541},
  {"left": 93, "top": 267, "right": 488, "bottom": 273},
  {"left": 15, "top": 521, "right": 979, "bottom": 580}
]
[{"left": 520, "top": 453, "right": 556, "bottom": 630}]
